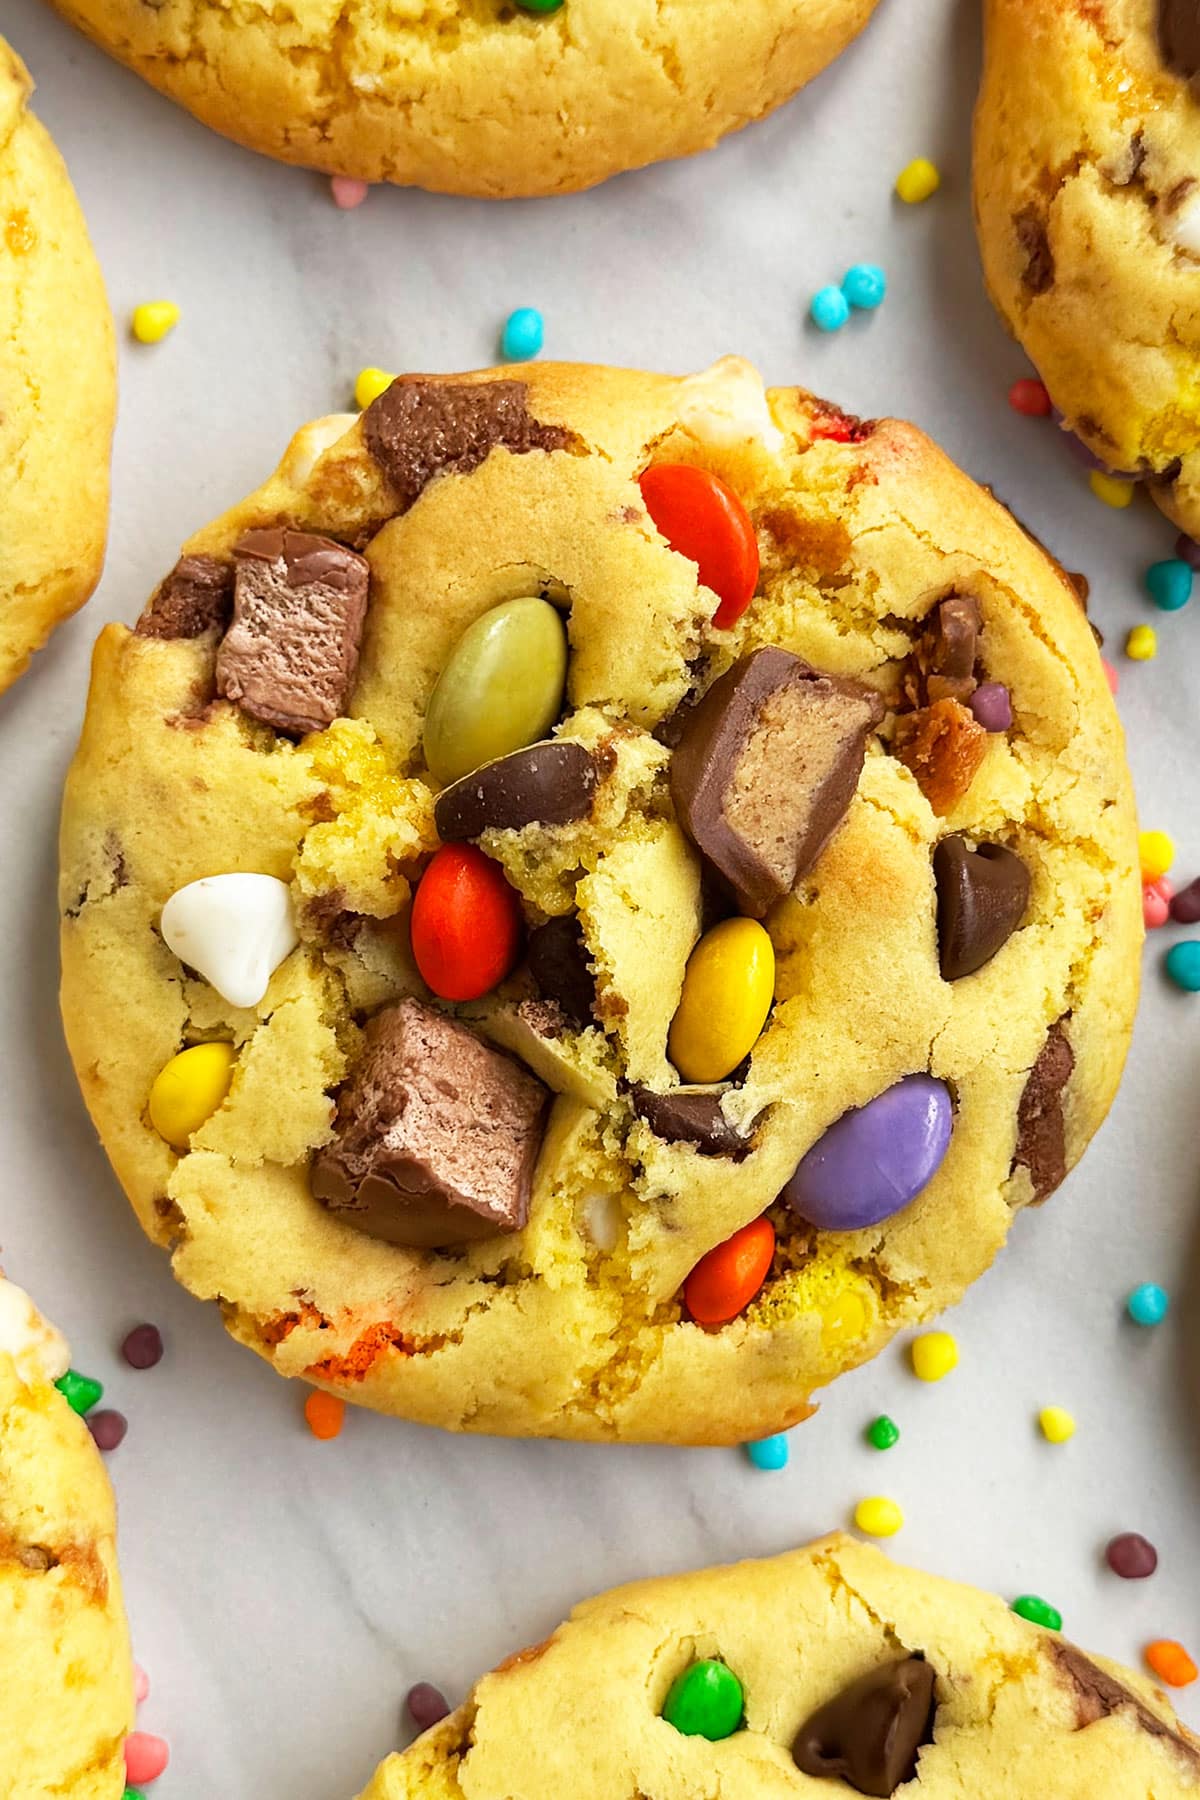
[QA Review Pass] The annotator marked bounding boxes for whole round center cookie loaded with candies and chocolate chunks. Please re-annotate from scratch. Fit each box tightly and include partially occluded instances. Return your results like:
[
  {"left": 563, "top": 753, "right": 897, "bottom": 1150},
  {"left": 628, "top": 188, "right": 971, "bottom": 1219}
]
[{"left": 61, "top": 358, "right": 1141, "bottom": 1442}]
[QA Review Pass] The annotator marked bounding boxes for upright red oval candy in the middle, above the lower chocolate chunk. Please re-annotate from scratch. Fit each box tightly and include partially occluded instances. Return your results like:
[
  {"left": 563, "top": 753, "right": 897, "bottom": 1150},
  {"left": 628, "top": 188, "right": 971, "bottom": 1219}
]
[{"left": 408, "top": 844, "right": 522, "bottom": 1001}]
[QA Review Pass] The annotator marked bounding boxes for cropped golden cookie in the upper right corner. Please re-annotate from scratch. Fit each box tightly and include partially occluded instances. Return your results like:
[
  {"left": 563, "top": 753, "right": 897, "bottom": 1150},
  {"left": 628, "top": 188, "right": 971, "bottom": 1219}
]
[{"left": 975, "top": 0, "right": 1200, "bottom": 536}]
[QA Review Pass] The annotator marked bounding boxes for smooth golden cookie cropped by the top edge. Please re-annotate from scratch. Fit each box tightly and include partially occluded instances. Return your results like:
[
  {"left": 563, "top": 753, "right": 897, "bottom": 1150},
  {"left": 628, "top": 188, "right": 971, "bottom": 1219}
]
[{"left": 44, "top": 0, "right": 876, "bottom": 198}]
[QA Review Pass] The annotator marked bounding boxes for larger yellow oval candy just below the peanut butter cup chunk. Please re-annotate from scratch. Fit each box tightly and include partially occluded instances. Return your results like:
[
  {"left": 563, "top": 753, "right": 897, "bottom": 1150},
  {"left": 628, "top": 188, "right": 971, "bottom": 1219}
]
[{"left": 667, "top": 918, "right": 775, "bottom": 1082}]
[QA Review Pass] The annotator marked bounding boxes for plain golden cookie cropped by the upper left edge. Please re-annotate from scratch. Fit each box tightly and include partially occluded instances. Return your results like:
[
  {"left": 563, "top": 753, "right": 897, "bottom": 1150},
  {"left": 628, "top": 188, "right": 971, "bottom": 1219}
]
[{"left": 0, "top": 38, "right": 117, "bottom": 693}]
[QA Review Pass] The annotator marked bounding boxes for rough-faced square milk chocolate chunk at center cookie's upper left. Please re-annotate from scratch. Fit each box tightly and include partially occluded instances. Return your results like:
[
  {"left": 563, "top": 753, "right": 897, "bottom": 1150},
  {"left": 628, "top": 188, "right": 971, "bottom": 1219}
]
[{"left": 216, "top": 526, "right": 371, "bottom": 736}]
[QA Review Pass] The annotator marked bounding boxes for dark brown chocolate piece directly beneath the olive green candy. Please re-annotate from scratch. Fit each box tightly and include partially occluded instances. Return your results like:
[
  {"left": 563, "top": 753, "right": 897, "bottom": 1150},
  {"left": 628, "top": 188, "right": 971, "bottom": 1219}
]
[{"left": 434, "top": 742, "right": 597, "bottom": 844}]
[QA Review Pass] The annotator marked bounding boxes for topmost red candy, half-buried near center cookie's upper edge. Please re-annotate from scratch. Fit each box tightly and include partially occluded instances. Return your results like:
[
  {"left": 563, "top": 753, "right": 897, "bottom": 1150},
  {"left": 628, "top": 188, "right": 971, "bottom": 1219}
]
[{"left": 639, "top": 463, "right": 759, "bottom": 630}]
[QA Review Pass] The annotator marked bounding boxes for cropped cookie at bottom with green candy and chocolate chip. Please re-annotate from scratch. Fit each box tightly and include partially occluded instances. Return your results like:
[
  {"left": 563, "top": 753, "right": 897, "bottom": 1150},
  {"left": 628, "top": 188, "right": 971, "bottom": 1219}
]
[{"left": 362, "top": 1534, "right": 1200, "bottom": 1800}]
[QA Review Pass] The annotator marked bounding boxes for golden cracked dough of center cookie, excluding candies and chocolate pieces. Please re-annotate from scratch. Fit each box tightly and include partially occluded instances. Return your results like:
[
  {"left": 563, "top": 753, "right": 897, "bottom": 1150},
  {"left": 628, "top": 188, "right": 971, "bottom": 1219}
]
[{"left": 61, "top": 358, "right": 1141, "bottom": 1444}]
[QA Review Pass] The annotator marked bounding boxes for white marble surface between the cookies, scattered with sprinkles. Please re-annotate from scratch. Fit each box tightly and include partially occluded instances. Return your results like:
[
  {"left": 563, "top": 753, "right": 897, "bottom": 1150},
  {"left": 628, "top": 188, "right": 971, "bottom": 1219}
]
[{"left": 0, "top": 0, "right": 1200, "bottom": 1800}]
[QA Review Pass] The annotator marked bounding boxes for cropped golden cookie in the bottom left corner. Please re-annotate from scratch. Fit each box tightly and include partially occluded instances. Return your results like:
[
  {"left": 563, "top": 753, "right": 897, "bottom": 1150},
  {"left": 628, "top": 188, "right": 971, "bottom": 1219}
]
[{"left": 0, "top": 1276, "right": 133, "bottom": 1800}]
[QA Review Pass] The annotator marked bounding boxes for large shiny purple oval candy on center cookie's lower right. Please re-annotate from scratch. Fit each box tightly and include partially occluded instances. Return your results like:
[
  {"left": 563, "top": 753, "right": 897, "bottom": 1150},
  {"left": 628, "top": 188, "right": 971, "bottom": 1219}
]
[{"left": 781, "top": 1075, "right": 954, "bottom": 1231}]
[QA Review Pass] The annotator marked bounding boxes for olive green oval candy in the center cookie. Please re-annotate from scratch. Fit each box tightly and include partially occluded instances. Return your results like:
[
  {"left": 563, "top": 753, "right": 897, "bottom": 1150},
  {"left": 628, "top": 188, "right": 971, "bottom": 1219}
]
[{"left": 425, "top": 599, "right": 567, "bottom": 787}]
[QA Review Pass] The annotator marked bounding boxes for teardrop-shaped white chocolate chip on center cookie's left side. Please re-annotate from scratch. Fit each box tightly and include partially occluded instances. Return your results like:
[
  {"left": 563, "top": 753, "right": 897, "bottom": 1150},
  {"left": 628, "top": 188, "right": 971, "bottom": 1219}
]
[{"left": 160, "top": 875, "right": 300, "bottom": 1006}]
